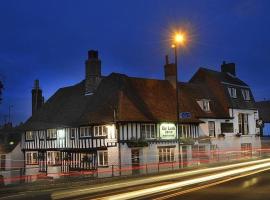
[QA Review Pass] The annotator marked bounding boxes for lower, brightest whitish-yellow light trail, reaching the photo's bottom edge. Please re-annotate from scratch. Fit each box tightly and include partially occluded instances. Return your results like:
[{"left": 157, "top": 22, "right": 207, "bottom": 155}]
[{"left": 102, "top": 163, "right": 270, "bottom": 200}]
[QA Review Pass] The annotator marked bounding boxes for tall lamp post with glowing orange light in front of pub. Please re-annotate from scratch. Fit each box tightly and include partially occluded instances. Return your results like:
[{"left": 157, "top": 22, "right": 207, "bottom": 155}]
[{"left": 172, "top": 33, "right": 185, "bottom": 167}]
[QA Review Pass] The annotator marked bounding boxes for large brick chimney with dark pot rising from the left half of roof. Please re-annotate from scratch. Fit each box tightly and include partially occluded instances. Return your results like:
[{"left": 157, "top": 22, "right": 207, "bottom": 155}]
[{"left": 85, "top": 50, "right": 101, "bottom": 94}]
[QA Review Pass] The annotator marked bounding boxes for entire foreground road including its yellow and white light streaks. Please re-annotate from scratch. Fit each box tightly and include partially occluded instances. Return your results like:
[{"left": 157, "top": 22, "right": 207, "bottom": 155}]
[{"left": 0, "top": 159, "right": 270, "bottom": 200}]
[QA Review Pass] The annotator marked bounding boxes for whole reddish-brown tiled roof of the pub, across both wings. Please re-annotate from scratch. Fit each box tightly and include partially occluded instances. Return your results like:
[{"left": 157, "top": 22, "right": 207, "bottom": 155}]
[{"left": 24, "top": 65, "right": 254, "bottom": 130}]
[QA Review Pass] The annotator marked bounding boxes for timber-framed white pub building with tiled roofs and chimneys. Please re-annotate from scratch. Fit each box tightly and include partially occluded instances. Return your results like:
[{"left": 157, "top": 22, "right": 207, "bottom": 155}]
[{"left": 21, "top": 50, "right": 260, "bottom": 177}]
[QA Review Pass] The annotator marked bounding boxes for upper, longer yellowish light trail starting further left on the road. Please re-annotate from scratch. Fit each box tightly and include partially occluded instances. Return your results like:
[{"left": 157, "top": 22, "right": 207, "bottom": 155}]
[{"left": 51, "top": 158, "right": 270, "bottom": 199}]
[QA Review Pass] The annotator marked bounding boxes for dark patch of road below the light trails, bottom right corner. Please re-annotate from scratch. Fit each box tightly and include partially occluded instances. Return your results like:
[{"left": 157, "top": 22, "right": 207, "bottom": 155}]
[{"left": 141, "top": 170, "right": 270, "bottom": 200}]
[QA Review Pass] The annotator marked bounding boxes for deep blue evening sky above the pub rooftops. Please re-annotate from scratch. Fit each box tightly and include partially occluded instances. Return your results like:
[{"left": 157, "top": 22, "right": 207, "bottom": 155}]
[{"left": 0, "top": 0, "right": 270, "bottom": 124}]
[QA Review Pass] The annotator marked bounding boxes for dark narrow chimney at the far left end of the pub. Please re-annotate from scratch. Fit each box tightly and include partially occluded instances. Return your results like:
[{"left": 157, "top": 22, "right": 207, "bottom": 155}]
[{"left": 32, "top": 80, "right": 44, "bottom": 115}]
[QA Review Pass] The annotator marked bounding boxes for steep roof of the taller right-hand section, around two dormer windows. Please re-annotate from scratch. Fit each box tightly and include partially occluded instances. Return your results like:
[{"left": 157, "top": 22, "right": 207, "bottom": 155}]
[{"left": 189, "top": 68, "right": 256, "bottom": 111}]
